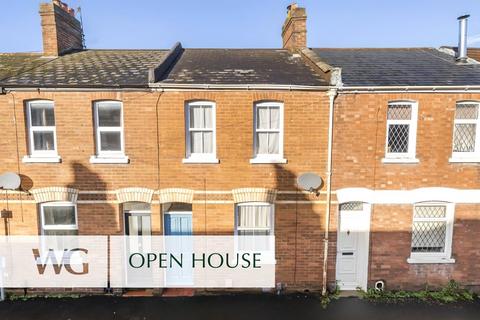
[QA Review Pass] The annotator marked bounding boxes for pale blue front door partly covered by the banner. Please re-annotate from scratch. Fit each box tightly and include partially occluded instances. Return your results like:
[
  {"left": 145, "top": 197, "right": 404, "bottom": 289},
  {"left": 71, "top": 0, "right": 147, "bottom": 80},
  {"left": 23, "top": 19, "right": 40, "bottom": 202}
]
[{"left": 164, "top": 212, "right": 193, "bottom": 288}]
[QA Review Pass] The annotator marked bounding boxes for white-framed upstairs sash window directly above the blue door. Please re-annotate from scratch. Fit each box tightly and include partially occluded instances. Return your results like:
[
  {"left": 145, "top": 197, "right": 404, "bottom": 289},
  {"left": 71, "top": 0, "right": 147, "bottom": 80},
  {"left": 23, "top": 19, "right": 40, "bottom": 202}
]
[{"left": 184, "top": 101, "right": 218, "bottom": 163}]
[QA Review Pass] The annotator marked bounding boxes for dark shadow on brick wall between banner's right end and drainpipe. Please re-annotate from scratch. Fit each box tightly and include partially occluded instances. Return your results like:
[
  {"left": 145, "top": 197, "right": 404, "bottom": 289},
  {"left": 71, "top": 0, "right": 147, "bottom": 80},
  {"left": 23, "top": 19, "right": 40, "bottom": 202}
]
[{"left": 274, "top": 164, "right": 325, "bottom": 289}]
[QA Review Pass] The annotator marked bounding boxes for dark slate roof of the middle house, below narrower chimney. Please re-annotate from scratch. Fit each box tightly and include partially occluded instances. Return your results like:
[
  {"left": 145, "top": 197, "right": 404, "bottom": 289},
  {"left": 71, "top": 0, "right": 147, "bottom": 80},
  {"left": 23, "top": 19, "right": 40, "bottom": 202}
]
[{"left": 162, "top": 49, "right": 328, "bottom": 86}]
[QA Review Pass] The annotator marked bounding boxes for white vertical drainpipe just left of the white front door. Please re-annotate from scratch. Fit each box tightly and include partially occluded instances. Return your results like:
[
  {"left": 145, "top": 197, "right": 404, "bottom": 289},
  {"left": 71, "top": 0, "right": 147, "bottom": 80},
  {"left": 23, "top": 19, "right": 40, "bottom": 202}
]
[{"left": 322, "top": 89, "right": 337, "bottom": 295}]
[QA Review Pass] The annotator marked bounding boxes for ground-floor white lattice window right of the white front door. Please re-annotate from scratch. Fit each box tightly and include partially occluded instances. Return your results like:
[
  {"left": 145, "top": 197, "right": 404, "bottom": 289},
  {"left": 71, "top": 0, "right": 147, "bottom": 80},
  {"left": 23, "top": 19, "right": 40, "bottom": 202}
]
[{"left": 411, "top": 202, "right": 454, "bottom": 262}]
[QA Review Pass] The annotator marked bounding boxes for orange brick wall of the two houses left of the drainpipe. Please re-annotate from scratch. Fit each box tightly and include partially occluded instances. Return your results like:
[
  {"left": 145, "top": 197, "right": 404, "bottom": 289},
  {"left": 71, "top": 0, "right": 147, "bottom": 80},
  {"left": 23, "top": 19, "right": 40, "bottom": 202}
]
[{"left": 0, "top": 91, "right": 328, "bottom": 289}]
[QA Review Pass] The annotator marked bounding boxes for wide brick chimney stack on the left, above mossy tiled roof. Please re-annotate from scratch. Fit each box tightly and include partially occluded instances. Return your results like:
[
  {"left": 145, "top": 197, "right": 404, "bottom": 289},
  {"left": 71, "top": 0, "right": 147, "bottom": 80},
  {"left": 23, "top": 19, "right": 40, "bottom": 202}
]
[{"left": 40, "top": 0, "right": 84, "bottom": 57}]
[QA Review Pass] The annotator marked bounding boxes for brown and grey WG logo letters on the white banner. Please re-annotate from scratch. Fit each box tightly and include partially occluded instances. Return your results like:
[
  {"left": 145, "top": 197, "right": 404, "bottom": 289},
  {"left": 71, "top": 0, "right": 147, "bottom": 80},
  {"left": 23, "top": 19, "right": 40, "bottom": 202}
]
[{"left": 32, "top": 248, "right": 88, "bottom": 275}]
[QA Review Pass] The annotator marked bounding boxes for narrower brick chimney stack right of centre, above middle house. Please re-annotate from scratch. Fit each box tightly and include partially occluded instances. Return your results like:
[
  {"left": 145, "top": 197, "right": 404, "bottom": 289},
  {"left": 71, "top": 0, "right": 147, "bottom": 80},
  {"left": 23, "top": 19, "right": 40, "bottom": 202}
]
[{"left": 282, "top": 3, "right": 307, "bottom": 49}]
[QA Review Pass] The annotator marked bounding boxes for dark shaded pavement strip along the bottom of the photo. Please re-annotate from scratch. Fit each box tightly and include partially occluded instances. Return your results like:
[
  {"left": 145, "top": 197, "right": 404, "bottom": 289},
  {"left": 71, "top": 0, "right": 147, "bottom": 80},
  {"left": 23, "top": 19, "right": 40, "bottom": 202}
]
[{"left": 0, "top": 294, "right": 480, "bottom": 320}]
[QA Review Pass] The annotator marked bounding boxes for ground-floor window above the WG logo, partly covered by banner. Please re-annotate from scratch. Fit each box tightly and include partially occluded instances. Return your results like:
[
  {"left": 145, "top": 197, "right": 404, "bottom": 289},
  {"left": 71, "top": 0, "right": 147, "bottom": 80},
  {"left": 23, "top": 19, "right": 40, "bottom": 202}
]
[{"left": 40, "top": 202, "right": 78, "bottom": 236}]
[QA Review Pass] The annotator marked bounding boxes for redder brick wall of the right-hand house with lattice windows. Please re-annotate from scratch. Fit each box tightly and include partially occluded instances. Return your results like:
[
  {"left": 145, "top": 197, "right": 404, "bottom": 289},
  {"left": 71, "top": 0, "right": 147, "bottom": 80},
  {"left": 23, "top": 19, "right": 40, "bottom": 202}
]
[{"left": 329, "top": 93, "right": 480, "bottom": 289}]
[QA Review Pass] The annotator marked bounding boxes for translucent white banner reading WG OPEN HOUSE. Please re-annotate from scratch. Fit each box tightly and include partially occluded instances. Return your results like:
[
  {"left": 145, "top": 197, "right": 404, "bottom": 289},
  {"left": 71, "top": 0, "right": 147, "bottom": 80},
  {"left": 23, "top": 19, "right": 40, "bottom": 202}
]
[{"left": 0, "top": 236, "right": 275, "bottom": 288}]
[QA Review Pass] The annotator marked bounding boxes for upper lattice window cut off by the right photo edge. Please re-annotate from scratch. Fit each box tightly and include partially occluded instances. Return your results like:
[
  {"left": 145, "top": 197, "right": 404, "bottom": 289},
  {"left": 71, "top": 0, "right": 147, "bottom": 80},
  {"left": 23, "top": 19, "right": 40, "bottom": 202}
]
[{"left": 452, "top": 102, "right": 480, "bottom": 161}]
